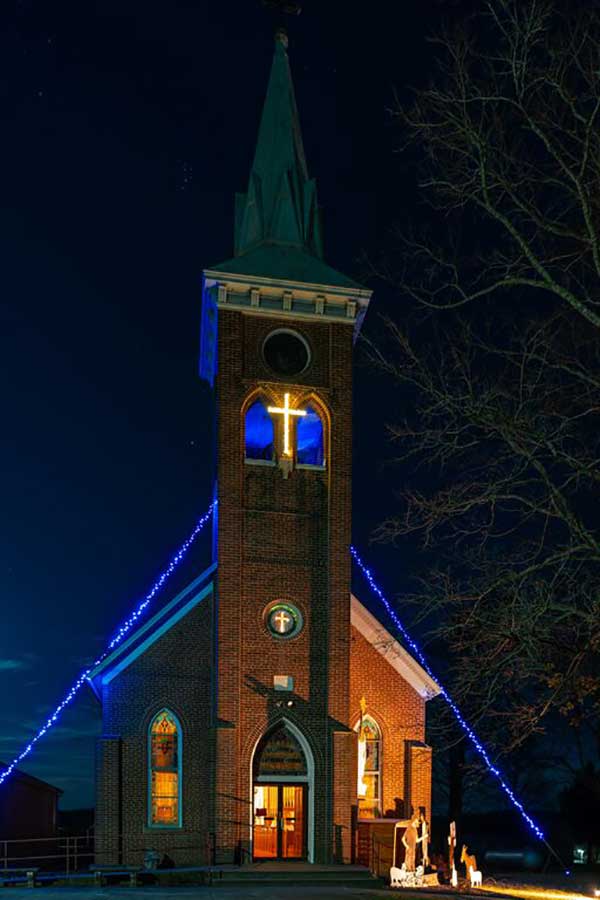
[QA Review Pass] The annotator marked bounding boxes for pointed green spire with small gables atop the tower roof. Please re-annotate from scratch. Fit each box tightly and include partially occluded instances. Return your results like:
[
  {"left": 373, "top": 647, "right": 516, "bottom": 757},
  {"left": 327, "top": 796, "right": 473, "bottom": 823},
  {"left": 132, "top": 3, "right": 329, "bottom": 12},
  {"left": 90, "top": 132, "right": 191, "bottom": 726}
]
[{"left": 235, "top": 29, "right": 323, "bottom": 258}]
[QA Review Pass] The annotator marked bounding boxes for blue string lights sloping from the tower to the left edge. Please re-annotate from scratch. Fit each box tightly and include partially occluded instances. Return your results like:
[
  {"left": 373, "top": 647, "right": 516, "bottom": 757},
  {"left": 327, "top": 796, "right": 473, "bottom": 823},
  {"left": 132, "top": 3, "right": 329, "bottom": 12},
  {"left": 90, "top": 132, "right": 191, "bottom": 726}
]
[{"left": 0, "top": 500, "right": 217, "bottom": 786}]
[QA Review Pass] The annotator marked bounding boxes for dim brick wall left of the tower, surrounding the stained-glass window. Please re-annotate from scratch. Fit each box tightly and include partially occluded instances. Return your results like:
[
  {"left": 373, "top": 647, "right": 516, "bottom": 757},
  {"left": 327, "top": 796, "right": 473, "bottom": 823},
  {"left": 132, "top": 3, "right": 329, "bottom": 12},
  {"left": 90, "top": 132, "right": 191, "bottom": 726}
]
[{"left": 96, "top": 596, "right": 212, "bottom": 865}]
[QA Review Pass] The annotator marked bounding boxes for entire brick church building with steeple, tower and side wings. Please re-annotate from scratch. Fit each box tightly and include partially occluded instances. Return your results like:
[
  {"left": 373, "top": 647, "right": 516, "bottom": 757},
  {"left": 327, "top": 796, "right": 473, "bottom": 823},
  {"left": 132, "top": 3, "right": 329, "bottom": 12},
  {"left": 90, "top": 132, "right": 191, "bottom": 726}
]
[{"left": 91, "top": 34, "right": 438, "bottom": 865}]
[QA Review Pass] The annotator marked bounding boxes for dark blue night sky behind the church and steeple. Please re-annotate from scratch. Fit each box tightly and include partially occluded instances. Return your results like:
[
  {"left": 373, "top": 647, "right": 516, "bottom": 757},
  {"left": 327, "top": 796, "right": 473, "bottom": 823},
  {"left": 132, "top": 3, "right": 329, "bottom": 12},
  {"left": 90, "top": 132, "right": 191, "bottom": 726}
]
[{"left": 0, "top": 0, "right": 446, "bottom": 808}]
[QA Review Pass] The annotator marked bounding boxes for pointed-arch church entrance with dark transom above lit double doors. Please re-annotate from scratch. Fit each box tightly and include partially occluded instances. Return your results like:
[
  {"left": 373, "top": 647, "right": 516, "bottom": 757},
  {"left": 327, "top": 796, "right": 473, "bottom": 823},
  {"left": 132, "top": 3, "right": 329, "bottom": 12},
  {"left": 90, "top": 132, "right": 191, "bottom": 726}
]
[{"left": 251, "top": 720, "right": 314, "bottom": 862}]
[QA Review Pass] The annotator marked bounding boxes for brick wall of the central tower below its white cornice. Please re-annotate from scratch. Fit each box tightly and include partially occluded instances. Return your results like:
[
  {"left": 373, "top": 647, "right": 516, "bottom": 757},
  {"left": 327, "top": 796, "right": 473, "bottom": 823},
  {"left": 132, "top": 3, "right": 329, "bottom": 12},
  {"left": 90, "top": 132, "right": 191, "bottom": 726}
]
[{"left": 215, "top": 309, "right": 352, "bottom": 861}]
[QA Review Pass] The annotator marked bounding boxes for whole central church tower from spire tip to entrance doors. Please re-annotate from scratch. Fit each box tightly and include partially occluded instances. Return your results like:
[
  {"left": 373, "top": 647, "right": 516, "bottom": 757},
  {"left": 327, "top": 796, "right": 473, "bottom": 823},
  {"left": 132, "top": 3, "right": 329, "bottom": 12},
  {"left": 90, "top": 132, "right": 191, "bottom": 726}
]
[{"left": 201, "top": 31, "right": 370, "bottom": 862}]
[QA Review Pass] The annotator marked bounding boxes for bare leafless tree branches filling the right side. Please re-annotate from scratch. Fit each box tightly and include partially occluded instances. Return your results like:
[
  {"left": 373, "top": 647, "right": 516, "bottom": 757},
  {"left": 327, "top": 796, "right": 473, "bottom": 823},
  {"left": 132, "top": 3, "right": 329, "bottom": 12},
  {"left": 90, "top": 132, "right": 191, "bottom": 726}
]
[{"left": 368, "top": 0, "right": 600, "bottom": 768}]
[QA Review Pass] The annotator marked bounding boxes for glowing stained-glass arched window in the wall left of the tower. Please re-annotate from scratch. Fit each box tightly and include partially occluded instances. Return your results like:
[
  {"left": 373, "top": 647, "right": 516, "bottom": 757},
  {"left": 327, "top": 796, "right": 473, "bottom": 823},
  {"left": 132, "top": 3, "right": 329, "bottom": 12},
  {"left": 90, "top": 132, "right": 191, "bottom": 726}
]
[{"left": 148, "top": 709, "right": 181, "bottom": 828}]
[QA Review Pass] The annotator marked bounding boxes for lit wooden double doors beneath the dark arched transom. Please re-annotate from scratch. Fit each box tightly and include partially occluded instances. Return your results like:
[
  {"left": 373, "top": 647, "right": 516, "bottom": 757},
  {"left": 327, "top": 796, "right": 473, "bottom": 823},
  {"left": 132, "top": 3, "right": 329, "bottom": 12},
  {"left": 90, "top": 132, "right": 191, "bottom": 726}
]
[{"left": 252, "top": 783, "right": 307, "bottom": 859}]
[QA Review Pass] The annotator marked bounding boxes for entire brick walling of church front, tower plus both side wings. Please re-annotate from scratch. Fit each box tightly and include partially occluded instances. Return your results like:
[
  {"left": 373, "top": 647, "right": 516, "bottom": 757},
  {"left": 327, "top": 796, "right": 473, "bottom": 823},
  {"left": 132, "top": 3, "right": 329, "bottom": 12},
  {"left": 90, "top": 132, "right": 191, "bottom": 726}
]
[{"left": 97, "top": 310, "right": 431, "bottom": 864}]
